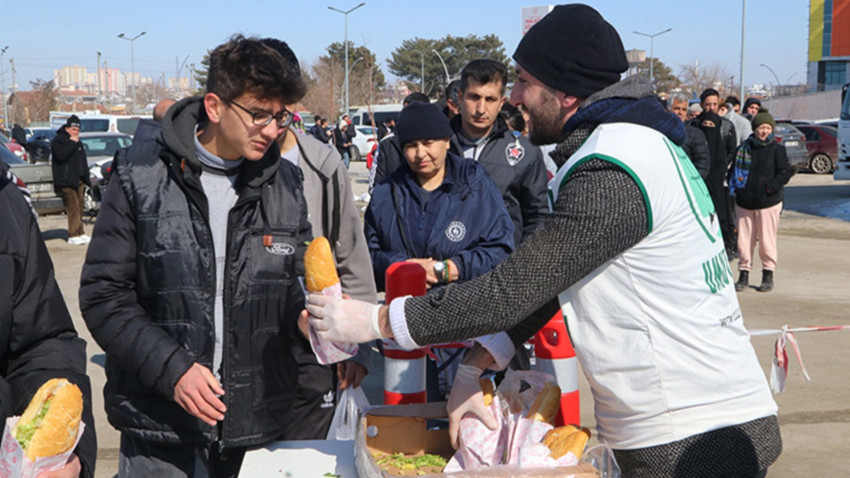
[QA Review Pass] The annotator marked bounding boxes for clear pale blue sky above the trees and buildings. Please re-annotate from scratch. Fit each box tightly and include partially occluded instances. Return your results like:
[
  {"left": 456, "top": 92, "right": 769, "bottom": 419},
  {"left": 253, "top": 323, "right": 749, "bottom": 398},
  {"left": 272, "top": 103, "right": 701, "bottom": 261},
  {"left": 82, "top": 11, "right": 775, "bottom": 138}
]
[{"left": 0, "top": 0, "right": 808, "bottom": 90}]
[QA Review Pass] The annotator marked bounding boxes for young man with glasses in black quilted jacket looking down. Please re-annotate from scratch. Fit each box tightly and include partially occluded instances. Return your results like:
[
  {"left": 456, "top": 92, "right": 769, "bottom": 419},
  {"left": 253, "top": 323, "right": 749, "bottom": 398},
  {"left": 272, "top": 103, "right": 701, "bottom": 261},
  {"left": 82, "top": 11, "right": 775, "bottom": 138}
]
[{"left": 80, "top": 36, "right": 311, "bottom": 477}]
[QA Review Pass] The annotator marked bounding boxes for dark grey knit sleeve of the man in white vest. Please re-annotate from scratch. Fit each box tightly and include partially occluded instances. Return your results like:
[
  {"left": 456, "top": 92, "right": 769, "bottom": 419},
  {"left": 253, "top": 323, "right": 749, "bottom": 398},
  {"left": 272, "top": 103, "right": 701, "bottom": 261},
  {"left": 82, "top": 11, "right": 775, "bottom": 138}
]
[{"left": 404, "top": 159, "right": 649, "bottom": 345}]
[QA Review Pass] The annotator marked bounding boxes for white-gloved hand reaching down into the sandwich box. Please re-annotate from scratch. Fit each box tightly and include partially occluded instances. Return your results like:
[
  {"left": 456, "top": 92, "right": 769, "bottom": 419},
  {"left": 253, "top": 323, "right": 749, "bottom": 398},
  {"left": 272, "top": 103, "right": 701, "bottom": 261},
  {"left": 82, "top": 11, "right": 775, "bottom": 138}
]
[{"left": 446, "top": 364, "right": 499, "bottom": 449}]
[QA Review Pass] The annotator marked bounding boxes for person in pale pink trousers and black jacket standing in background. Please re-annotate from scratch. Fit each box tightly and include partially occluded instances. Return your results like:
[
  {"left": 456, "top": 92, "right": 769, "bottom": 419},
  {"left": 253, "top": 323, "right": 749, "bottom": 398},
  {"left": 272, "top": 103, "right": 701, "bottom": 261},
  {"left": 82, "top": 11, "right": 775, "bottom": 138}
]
[{"left": 729, "top": 109, "right": 796, "bottom": 292}]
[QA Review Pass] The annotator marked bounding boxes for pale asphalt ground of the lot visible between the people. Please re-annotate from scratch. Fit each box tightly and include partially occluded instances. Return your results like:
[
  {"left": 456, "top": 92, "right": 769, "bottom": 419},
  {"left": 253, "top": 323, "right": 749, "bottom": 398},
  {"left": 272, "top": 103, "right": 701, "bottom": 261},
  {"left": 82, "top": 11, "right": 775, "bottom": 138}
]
[{"left": 39, "top": 162, "right": 850, "bottom": 478}]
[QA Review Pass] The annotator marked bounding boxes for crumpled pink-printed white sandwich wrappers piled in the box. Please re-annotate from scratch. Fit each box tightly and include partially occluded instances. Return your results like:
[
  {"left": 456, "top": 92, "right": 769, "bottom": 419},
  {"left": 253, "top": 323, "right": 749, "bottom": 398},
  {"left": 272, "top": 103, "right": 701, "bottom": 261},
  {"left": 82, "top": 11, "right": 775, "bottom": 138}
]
[{"left": 443, "top": 370, "right": 578, "bottom": 473}]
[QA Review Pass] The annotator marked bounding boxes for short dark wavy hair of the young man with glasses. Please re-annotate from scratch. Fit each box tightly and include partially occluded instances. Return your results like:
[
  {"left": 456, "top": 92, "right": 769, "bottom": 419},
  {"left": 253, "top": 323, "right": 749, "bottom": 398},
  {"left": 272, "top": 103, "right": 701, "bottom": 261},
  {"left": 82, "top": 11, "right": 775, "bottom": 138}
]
[{"left": 207, "top": 35, "right": 307, "bottom": 104}]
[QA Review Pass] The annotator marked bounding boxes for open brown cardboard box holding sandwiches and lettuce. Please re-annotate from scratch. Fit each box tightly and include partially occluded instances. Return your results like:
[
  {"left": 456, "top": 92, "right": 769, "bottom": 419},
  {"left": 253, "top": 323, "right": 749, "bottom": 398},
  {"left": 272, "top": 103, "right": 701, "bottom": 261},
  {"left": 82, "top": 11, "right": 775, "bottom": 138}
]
[{"left": 354, "top": 402, "right": 599, "bottom": 478}]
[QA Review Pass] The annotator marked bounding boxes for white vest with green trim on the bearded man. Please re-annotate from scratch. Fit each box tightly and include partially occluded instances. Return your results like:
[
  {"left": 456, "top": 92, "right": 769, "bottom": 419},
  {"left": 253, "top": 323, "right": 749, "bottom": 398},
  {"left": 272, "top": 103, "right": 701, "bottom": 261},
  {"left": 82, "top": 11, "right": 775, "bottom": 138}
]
[{"left": 549, "top": 123, "right": 777, "bottom": 449}]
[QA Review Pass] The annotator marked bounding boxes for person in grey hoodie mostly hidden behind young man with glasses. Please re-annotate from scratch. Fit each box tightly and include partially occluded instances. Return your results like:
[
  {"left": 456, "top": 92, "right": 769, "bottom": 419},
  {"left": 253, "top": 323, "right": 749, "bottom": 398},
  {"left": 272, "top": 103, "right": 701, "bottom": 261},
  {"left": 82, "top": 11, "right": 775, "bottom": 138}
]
[{"left": 263, "top": 38, "right": 377, "bottom": 440}]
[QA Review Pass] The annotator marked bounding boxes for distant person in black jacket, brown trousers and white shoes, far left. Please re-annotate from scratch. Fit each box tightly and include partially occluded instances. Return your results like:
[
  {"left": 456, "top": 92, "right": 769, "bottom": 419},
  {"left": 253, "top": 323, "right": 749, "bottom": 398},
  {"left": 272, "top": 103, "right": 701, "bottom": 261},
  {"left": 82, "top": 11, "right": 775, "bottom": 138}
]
[{"left": 50, "top": 115, "right": 91, "bottom": 246}]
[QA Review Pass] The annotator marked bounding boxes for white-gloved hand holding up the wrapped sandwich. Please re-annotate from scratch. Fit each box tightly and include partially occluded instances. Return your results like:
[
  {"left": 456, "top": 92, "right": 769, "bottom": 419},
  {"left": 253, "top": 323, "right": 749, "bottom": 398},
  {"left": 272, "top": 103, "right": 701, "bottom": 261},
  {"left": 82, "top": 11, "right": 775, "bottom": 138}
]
[{"left": 307, "top": 294, "right": 381, "bottom": 344}]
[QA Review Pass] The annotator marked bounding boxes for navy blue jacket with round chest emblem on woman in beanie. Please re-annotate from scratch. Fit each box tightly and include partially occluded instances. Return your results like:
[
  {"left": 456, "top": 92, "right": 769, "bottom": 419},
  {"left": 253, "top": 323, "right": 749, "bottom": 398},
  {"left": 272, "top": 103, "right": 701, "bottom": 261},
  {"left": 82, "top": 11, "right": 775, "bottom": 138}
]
[{"left": 365, "top": 152, "right": 514, "bottom": 290}]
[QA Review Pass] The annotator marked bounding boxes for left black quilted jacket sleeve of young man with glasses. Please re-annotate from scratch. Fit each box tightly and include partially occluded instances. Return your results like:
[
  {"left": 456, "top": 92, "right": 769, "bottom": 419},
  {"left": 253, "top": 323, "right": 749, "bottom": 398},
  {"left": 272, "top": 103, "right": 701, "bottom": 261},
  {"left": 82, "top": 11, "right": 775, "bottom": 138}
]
[{"left": 79, "top": 166, "right": 195, "bottom": 399}]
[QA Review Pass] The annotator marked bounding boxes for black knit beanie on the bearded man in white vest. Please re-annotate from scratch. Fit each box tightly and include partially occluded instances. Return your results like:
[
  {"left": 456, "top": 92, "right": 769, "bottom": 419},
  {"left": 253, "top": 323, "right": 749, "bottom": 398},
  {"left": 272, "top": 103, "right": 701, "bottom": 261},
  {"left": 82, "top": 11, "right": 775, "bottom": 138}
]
[{"left": 514, "top": 4, "right": 629, "bottom": 98}]
